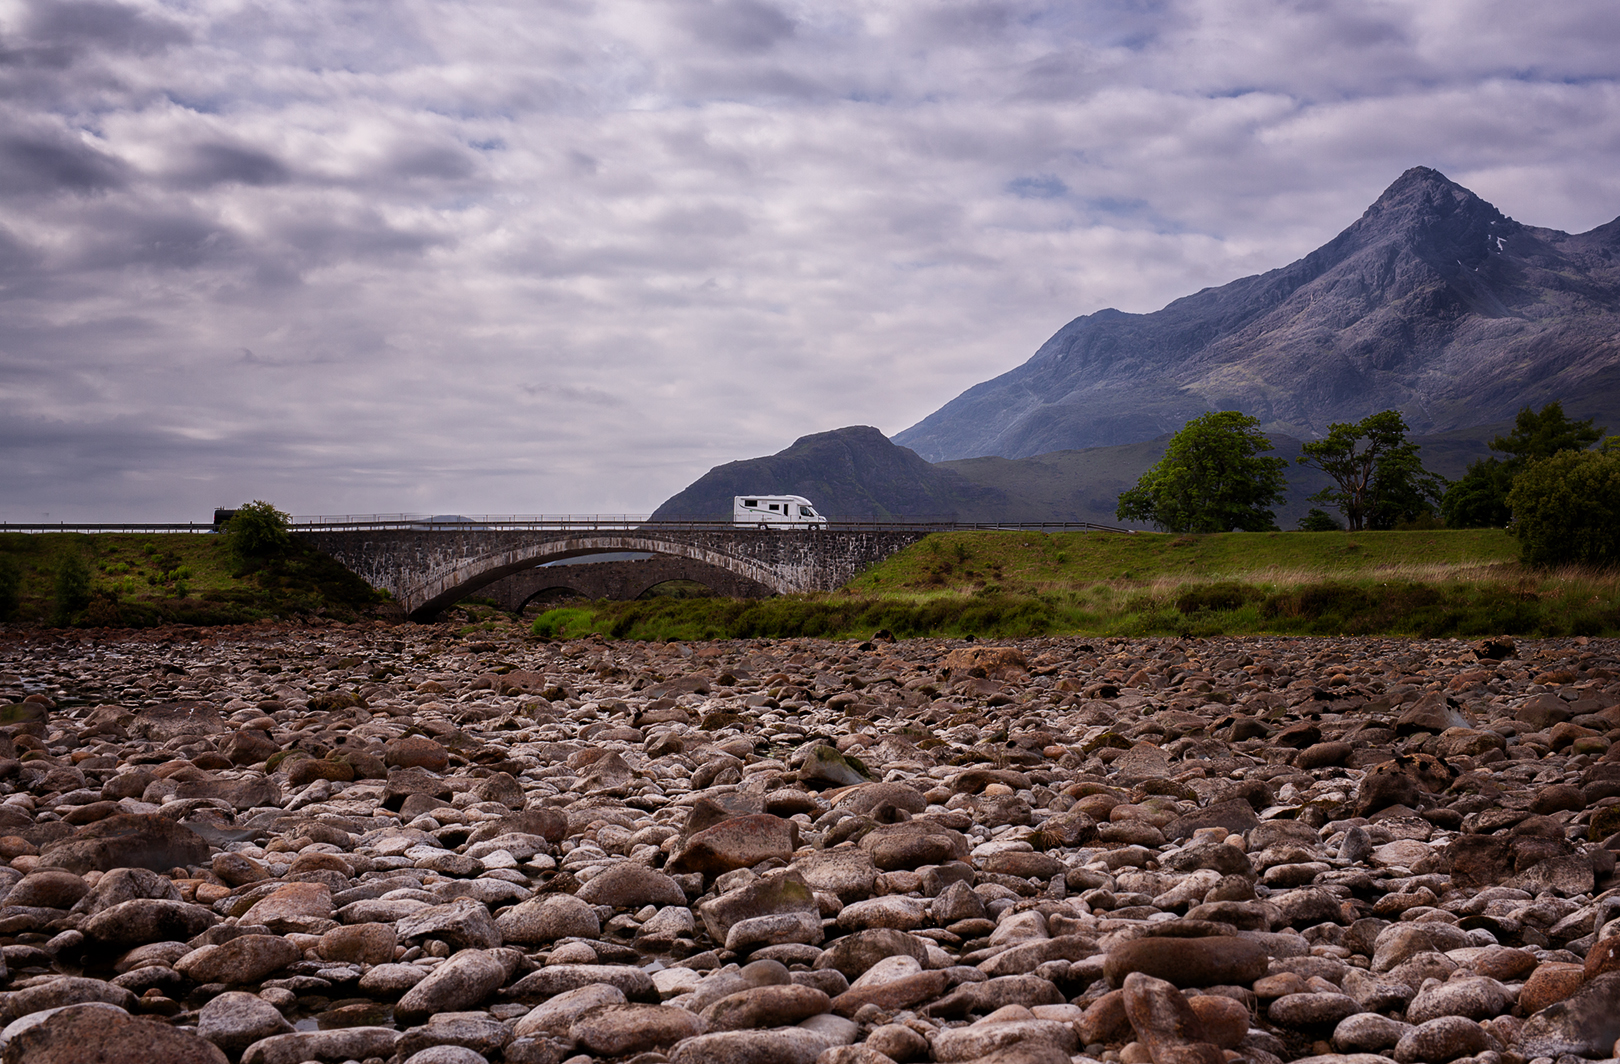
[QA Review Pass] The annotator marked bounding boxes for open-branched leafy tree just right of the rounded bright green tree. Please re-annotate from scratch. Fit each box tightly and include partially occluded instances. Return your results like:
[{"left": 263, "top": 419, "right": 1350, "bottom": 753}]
[{"left": 1298, "top": 410, "right": 1445, "bottom": 531}]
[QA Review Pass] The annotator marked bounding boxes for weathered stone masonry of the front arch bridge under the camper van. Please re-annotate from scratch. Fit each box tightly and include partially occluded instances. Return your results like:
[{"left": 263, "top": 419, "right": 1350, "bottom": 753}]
[{"left": 295, "top": 526, "right": 927, "bottom": 620}]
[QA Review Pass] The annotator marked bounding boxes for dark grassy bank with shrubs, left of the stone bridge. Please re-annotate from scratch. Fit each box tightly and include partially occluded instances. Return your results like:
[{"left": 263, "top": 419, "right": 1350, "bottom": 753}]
[{"left": 0, "top": 533, "right": 386, "bottom": 628}]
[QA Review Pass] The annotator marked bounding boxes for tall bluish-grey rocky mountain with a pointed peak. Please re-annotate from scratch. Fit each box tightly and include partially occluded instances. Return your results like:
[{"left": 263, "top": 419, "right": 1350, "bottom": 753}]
[{"left": 894, "top": 167, "right": 1620, "bottom": 459}]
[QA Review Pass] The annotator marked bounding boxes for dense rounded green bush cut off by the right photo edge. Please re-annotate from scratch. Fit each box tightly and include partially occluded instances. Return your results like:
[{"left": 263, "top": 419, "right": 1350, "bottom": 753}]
[{"left": 1508, "top": 447, "right": 1620, "bottom": 567}]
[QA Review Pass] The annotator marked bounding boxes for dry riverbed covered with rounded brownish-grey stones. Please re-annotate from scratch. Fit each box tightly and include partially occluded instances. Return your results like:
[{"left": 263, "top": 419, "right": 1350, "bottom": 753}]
[{"left": 0, "top": 624, "right": 1620, "bottom": 1064}]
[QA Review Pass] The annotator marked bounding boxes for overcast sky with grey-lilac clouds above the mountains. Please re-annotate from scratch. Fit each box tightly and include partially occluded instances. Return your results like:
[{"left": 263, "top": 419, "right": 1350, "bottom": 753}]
[{"left": 0, "top": 0, "right": 1620, "bottom": 521}]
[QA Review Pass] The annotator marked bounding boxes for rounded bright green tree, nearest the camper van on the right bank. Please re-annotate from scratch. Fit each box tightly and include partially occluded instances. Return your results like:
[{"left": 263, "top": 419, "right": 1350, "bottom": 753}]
[{"left": 1116, "top": 410, "right": 1288, "bottom": 533}]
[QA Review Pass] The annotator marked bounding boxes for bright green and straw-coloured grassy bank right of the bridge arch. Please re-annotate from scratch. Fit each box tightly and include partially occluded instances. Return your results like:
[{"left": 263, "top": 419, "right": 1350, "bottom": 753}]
[{"left": 535, "top": 530, "right": 1620, "bottom": 640}]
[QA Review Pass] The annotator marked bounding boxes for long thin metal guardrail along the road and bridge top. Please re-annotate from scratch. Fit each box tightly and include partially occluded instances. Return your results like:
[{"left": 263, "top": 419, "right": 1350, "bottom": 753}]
[{"left": 0, "top": 513, "right": 1136, "bottom": 534}]
